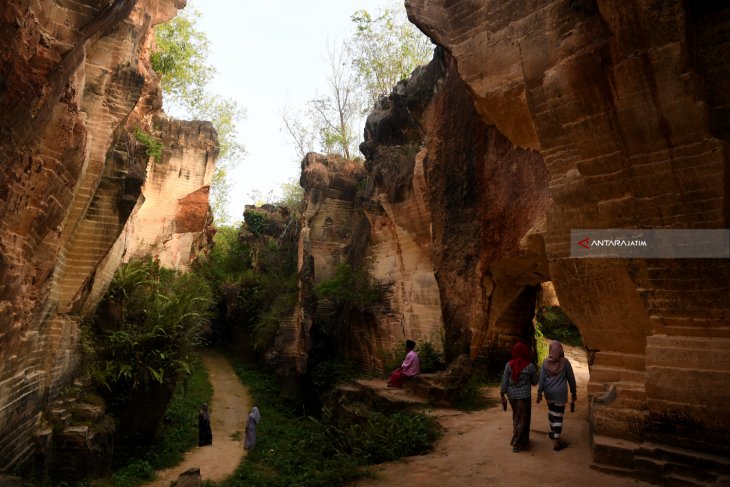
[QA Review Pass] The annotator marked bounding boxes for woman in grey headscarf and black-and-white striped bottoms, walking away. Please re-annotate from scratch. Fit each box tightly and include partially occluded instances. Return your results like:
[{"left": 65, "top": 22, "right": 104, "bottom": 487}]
[{"left": 537, "top": 340, "right": 576, "bottom": 451}]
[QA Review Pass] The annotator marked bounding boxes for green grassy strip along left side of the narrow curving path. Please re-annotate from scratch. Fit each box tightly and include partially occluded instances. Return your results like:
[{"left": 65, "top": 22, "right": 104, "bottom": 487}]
[{"left": 112, "top": 359, "right": 213, "bottom": 487}]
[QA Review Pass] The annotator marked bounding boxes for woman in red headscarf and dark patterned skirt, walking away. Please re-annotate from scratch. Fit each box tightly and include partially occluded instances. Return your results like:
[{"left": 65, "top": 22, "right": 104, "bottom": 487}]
[{"left": 499, "top": 342, "right": 537, "bottom": 453}]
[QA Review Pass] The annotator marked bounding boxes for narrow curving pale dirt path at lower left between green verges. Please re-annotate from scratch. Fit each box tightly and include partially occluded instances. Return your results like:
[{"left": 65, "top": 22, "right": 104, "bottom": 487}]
[{"left": 148, "top": 351, "right": 252, "bottom": 487}]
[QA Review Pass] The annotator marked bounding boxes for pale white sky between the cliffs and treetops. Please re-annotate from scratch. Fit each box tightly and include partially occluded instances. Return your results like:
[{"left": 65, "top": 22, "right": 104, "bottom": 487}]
[{"left": 171, "top": 0, "right": 398, "bottom": 221}]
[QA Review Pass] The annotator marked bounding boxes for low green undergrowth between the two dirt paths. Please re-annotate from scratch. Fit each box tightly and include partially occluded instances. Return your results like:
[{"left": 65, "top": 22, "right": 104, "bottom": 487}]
[{"left": 222, "top": 363, "right": 438, "bottom": 487}]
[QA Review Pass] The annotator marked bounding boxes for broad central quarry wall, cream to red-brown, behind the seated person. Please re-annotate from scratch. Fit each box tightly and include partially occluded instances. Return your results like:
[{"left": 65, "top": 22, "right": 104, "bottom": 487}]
[{"left": 278, "top": 49, "right": 549, "bottom": 373}]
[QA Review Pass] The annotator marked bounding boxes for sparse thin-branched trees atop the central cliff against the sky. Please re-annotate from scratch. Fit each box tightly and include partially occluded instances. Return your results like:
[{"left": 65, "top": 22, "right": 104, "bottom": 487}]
[{"left": 282, "top": 5, "right": 433, "bottom": 160}]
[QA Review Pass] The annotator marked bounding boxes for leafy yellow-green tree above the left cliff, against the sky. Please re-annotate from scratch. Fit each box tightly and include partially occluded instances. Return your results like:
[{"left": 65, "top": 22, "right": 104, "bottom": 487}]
[{"left": 150, "top": 9, "right": 245, "bottom": 221}]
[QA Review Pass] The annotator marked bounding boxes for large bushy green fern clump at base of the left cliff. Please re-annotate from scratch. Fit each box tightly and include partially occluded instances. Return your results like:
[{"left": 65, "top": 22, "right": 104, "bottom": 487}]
[{"left": 86, "top": 258, "right": 213, "bottom": 394}]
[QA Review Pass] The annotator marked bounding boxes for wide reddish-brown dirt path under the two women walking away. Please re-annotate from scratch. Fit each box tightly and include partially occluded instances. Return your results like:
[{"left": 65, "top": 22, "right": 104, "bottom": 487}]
[{"left": 346, "top": 347, "right": 649, "bottom": 487}]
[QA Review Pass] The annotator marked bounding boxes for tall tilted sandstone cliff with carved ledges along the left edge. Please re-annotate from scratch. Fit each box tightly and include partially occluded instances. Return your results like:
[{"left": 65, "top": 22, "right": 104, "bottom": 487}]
[{"left": 0, "top": 0, "right": 199, "bottom": 469}]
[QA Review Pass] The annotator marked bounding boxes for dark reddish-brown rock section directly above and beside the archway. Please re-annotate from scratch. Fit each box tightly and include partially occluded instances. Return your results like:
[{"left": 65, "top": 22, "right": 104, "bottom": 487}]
[{"left": 416, "top": 54, "right": 550, "bottom": 369}]
